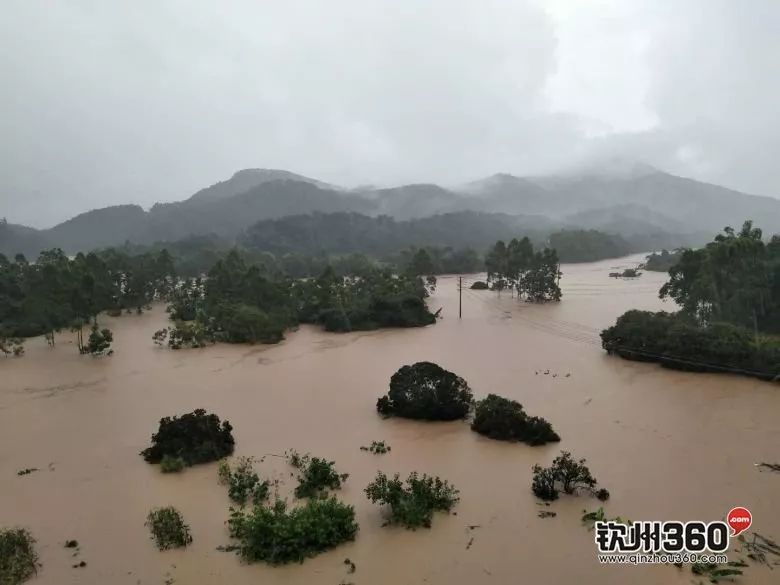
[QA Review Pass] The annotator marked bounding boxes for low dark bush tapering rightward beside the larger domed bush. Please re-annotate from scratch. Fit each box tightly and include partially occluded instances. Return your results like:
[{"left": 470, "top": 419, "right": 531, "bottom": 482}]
[{"left": 471, "top": 394, "right": 561, "bottom": 445}]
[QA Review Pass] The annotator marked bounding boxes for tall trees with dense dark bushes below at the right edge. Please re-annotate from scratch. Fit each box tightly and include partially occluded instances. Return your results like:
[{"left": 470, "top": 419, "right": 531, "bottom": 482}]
[{"left": 601, "top": 221, "right": 780, "bottom": 379}]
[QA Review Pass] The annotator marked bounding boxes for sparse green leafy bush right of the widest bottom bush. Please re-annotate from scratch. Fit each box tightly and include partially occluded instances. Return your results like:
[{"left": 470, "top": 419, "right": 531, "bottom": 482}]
[{"left": 365, "top": 471, "right": 460, "bottom": 529}]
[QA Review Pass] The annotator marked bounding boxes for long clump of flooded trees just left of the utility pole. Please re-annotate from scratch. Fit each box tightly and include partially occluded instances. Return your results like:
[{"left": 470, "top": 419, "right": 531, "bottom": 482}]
[{"left": 165, "top": 250, "right": 435, "bottom": 347}]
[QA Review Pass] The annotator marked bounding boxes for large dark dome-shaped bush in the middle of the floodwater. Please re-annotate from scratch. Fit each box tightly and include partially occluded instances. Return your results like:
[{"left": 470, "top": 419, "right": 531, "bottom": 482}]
[{"left": 376, "top": 362, "right": 473, "bottom": 420}]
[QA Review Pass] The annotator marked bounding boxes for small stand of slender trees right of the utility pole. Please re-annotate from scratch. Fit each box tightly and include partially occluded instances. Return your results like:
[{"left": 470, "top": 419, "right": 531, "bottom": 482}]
[{"left": 485, "top": 238, "right": 561, "bottom": 302}]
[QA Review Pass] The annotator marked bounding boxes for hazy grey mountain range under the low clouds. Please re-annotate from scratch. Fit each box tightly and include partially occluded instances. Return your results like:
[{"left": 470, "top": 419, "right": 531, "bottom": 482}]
[{"left": 0, "top": 165, "right": 780, "bottom": 257}]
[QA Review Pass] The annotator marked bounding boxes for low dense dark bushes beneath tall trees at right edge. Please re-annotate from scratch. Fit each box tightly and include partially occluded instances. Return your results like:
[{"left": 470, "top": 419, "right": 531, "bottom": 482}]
[{"left": 601, "top": 310, "right": 780, "bottom": 380}]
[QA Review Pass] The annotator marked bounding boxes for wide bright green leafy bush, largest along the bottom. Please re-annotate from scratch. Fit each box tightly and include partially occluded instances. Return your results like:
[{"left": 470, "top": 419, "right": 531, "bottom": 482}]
[{"left": 228, "top": 497, "right": 358, "bottom": 565}]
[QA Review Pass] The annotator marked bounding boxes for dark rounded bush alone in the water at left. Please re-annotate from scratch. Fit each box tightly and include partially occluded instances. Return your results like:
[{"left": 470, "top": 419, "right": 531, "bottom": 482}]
[{"left": 141, "top": 408, "right": 235, "bottom": 465}]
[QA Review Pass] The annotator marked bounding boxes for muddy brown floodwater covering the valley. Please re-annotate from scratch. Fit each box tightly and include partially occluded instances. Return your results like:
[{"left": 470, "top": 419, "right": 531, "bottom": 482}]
[{"left": 0, "top": 257, "right": 780, "bottom": 585}]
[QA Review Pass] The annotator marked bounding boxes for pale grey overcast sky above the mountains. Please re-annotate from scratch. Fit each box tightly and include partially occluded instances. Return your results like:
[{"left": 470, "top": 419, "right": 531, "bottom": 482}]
[{"left": 0, "top": 0, "right": 780, "bottom": 227}]
